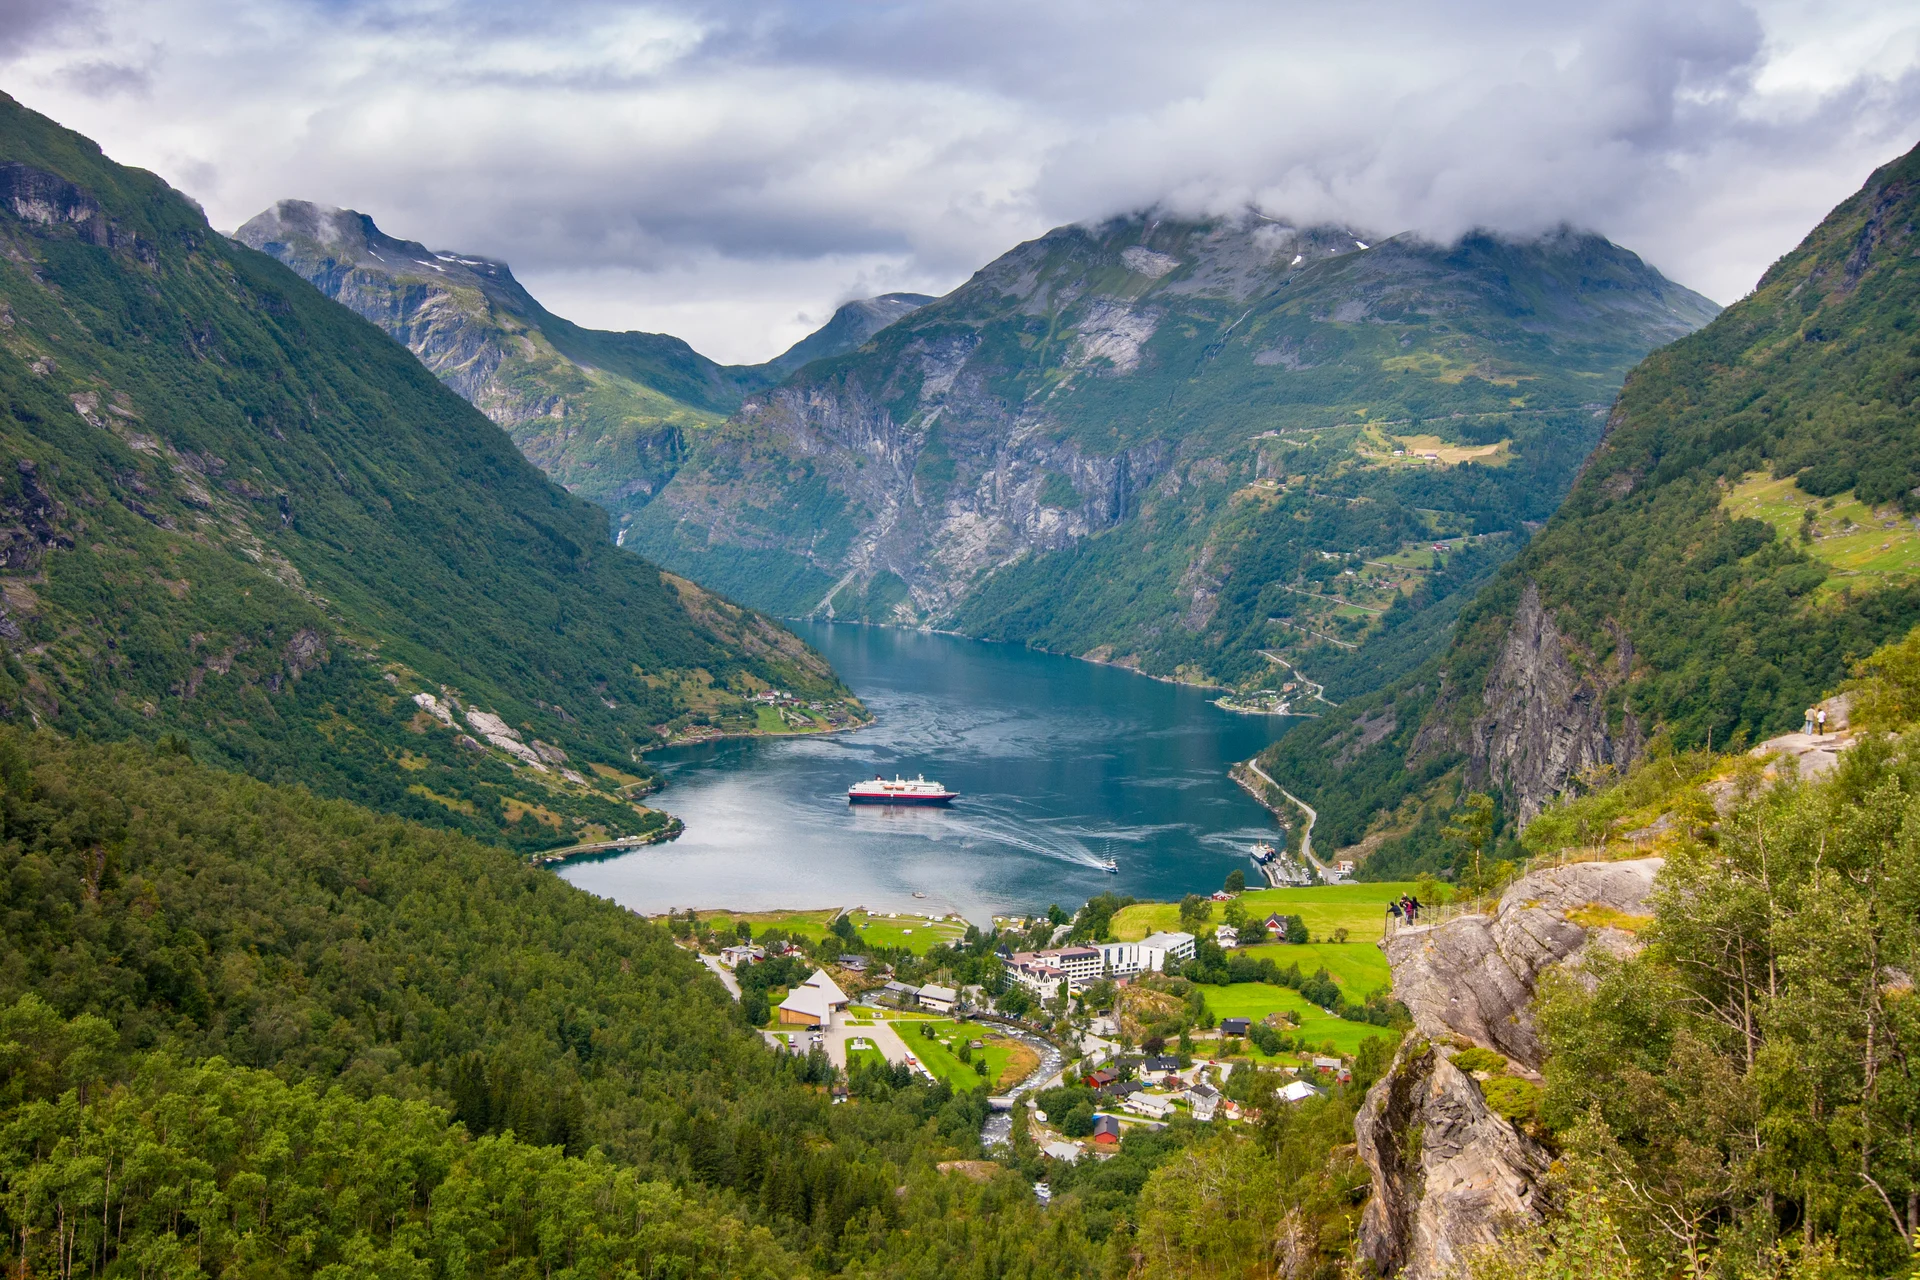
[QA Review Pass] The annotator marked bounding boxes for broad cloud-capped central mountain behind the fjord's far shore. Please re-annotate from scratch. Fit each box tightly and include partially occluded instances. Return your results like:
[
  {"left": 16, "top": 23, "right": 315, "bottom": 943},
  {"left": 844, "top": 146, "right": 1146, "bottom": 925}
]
[{"left": 628, "top": 217, "right": 1716, "bottom": 683}]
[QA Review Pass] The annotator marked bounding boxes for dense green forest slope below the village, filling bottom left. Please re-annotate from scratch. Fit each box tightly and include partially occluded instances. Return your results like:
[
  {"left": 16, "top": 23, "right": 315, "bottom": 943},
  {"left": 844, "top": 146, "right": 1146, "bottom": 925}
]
[{"left": 0, "top": 727, "right": 1382, "bottom": 1280}]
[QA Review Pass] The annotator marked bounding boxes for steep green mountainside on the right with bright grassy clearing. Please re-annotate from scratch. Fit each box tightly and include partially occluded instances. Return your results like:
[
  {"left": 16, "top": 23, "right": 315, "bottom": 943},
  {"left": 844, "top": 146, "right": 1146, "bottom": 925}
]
[{"left": 1265, "top": 140, "right": 1920, "bottom": 875}]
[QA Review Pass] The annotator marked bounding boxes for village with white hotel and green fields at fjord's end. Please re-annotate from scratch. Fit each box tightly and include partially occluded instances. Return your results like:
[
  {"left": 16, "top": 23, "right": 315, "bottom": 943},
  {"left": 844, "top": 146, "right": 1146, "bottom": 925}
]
[{"left": 666, "top": 885, "right": 1411, "bottom": 1194}]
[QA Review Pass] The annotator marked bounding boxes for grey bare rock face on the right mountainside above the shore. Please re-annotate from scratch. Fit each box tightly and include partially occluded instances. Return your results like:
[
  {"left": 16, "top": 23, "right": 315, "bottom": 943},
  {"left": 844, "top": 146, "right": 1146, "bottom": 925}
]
[{"left": 1469, "top": 583, "right": 1640, "bottom": 825}]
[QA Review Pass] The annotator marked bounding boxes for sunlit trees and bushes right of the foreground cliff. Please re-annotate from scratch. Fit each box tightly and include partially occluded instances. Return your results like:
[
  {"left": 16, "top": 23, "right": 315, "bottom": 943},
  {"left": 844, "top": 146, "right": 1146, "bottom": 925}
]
[{"left": 1455, "top": 633, "right": 1920, "bottom": 1280}]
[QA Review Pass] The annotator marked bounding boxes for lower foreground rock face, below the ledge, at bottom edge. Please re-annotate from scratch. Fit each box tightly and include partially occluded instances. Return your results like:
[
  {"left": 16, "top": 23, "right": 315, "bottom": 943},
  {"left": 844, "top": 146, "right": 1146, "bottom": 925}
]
[{"left": 1354, "top": 1036, "right": 1549, "bottom": 1280}]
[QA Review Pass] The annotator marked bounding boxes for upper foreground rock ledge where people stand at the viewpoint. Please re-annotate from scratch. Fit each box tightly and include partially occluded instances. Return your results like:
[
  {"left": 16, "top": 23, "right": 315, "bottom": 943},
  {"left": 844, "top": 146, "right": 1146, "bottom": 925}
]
[{"left": 1384, "top": 858, "right": 1663, "bottom": 1071}]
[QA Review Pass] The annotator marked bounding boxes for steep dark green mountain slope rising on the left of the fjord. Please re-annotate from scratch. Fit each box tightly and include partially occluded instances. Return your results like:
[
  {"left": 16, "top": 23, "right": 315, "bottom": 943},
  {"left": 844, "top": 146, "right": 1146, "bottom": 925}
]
[{"left": 0, "top": 98, "right": 862, "bottom": 848}]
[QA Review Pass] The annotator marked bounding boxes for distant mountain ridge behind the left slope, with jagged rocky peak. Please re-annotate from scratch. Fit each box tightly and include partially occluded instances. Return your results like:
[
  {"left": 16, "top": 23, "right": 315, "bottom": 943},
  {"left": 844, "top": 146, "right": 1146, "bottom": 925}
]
[{"left": 234, "top": 200, "right": 931, "bottom": 522}]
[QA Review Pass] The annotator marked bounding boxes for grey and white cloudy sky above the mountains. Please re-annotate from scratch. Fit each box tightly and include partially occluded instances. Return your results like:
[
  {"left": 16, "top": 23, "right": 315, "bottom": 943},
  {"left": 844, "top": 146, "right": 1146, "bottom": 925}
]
[{"left": 0, "top": 0, "right": 1920, "bottom": 361}]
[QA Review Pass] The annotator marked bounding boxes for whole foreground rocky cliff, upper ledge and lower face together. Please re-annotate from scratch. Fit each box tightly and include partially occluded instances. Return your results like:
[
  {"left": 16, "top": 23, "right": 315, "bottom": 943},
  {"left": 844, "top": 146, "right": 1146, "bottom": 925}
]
[{"left": 1354, "top": 858, "right": 1663, "bottom": 1280}]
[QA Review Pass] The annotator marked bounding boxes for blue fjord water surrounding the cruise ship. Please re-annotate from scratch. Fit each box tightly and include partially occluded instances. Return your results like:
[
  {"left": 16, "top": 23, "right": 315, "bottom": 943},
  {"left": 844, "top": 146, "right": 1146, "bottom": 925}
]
[{"left": 563, "top": 624, "right": 1292, "bottom": 923}]
